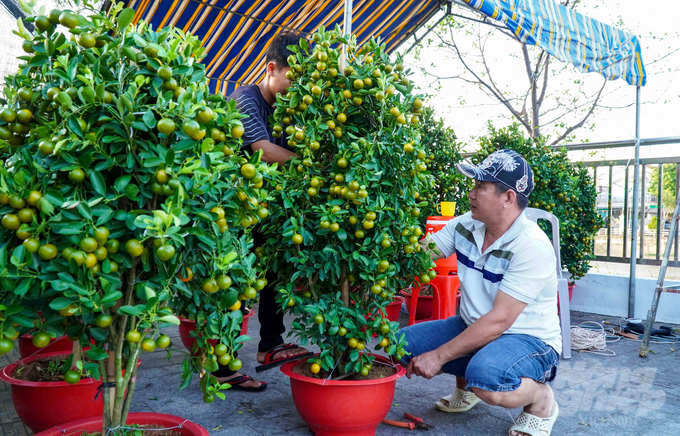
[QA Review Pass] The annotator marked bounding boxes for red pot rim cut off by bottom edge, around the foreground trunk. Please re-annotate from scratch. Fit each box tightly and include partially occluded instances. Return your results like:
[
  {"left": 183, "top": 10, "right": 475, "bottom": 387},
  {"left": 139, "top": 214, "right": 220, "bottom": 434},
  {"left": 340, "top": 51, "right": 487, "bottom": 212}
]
[{"left": 35, "top": 412, "right": 210, "bottom": 436}]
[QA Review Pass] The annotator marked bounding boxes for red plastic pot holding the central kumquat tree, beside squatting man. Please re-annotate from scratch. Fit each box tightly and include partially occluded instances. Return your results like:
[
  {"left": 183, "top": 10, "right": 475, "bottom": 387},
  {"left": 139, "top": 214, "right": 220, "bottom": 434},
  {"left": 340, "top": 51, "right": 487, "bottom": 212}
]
[{"left": 281, "top": 356, "right": 406, "bottom": 436}]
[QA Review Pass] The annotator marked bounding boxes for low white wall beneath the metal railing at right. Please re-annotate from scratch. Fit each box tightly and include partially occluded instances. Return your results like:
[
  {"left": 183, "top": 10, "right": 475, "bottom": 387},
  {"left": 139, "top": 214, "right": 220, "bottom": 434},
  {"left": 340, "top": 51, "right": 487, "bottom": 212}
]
[{"left": 570, "top": 274, "right": 680, "bottom": 324}]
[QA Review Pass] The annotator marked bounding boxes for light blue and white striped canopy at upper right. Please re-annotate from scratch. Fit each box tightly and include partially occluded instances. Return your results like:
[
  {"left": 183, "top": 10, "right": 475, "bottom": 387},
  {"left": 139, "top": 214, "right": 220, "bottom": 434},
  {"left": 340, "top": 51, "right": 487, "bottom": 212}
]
[{"left": 463, "top": 0, "right": 647, "bottom": 86}]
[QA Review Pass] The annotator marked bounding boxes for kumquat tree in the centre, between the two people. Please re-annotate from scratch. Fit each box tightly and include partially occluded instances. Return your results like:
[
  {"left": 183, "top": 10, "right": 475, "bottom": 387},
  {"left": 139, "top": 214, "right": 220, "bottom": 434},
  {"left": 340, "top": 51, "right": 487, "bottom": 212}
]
[{"left": 263, "top": 28, "right": 435, "bottom": 378}]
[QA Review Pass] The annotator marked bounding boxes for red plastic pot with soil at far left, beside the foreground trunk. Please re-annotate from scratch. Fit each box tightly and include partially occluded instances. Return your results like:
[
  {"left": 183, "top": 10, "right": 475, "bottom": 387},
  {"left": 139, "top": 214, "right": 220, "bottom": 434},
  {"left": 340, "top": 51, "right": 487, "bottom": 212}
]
[{"left": 0, "top": 350, "right": 139, "bottom": 433}]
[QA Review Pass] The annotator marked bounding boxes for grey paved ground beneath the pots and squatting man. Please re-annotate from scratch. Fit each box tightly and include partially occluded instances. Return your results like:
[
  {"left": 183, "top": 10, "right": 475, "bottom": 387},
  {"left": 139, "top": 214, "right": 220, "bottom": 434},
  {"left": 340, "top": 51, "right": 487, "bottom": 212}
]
[{"left": 0, "top": 312, "right": 680, "bottom": 436}]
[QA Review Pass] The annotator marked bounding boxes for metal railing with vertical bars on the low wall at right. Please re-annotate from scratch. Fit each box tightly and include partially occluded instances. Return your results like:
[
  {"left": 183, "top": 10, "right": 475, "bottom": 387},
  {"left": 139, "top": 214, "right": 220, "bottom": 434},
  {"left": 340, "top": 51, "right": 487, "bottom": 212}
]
[{"left": 565, "top": 137, "right": 680, "bottom": 267}]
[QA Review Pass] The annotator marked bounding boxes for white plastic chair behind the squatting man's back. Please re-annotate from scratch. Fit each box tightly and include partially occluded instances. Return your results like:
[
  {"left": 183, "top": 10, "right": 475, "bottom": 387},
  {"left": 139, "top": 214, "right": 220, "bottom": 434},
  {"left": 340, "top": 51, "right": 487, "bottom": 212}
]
[{"left": 524, "top": 207, "right": 571, "bottom": 359}]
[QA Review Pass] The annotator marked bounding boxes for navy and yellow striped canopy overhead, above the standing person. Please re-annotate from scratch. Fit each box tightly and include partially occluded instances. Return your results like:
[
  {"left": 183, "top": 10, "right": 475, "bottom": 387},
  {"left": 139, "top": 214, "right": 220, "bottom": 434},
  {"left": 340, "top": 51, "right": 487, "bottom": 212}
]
[{"left": 126, "top": 0, "right": 440, "bottom": 95}]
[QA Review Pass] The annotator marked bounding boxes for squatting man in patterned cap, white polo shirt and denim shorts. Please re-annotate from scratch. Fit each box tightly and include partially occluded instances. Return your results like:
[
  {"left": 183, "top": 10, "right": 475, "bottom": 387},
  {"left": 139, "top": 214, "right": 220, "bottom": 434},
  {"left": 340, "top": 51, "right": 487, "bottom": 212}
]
[{"left": 402, "top": 150, "right": 569, "bottom": 436}]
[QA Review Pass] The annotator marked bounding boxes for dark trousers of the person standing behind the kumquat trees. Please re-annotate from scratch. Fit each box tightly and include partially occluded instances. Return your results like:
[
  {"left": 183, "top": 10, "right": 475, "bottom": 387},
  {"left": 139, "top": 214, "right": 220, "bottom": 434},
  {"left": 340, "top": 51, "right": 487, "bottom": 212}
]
[{"left": 213, "top": 229, "right": 286, "bottom": 377}]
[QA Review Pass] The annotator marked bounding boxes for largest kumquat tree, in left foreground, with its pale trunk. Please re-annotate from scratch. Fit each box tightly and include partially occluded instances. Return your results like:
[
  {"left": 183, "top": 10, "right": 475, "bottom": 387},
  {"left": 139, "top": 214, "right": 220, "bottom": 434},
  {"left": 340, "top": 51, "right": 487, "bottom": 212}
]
[{"left": 0, "top": 3, "right": 272, "bottom": 434}]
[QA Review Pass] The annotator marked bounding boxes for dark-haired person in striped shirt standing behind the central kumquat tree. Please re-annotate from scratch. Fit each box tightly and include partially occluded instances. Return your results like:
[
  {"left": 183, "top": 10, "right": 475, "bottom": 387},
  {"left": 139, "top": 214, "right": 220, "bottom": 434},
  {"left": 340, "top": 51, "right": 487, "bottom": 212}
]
[{"left": 213, "top": 32, "right": 309, "bottom": 391}]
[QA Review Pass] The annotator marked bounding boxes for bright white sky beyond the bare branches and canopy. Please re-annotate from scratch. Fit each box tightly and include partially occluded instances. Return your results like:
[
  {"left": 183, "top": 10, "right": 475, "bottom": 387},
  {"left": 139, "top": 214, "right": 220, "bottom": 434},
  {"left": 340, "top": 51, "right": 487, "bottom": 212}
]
[{"left": 400, "top": 0, "right": 680, "bottom": 164}]
